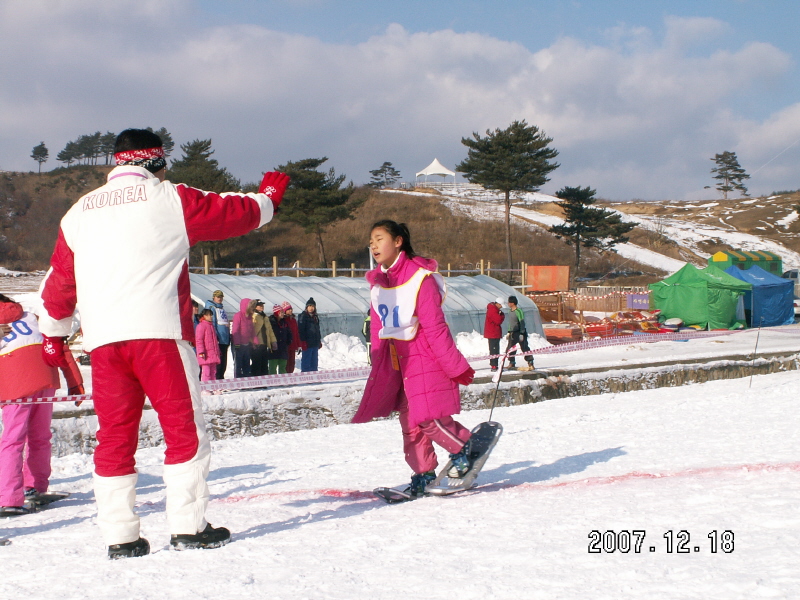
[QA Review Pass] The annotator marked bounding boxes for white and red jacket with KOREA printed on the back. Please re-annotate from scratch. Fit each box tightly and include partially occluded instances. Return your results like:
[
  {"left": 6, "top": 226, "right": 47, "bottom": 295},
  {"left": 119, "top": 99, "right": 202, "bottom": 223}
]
[{"left": 39, "top": 166, "right": 273, "bottom": 351}]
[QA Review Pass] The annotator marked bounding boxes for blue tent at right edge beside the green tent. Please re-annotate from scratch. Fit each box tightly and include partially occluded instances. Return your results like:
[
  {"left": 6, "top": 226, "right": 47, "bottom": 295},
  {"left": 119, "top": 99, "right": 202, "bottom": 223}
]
[{"left": 725, "top": 265, "right": 794, "bottom": 327}]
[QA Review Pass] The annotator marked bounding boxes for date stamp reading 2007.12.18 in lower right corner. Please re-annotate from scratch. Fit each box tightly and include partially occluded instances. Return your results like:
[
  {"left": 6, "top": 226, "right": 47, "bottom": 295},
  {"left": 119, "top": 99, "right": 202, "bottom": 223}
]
[{"left": 589, "top": 529, "right": 734, "bottom": 554}]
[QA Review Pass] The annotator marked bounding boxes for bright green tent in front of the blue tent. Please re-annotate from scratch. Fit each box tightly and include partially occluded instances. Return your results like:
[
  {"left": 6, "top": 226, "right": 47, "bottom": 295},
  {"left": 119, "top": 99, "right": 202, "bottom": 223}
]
[{"left": 648, "top": 263, "right": 753, "bottom": 329}]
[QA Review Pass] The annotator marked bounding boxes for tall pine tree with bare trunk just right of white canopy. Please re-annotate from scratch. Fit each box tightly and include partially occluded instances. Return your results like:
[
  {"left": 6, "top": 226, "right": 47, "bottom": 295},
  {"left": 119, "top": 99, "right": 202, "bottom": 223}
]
[{"left": 456, "top": 120, "right": 559, "bottom": 268}]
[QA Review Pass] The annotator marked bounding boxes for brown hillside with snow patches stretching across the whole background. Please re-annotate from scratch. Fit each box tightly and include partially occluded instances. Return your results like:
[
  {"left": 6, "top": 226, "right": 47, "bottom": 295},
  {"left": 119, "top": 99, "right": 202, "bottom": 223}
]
[{"left": 0, "top": 166, "right": 800, "bottom": 285}]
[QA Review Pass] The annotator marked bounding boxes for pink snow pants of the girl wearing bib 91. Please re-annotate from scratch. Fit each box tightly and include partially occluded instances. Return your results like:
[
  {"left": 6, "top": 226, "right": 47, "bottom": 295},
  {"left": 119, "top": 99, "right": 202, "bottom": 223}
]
[{"left": 398, "top": 394, "right": 470, "bottom": 473}]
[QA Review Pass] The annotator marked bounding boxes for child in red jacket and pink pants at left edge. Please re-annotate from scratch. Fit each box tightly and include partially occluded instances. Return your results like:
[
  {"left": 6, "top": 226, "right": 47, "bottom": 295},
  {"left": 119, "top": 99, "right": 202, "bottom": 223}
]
[{"left": 0, "top": 294, "right": 83, "bottom": 517}]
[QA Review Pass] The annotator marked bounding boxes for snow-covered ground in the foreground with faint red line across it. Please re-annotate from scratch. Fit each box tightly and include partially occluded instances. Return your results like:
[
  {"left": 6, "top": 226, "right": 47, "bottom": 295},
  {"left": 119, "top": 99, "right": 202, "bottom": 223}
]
[{"left": 0, "top": 372, "right": 800, "bottom": 600}]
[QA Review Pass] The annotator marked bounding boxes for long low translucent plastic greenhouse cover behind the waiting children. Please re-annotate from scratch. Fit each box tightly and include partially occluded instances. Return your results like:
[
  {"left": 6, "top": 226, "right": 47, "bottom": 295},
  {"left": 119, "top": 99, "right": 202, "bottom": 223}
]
[{"left": 189, "top": 274, "right": 544, "bottom": 337}]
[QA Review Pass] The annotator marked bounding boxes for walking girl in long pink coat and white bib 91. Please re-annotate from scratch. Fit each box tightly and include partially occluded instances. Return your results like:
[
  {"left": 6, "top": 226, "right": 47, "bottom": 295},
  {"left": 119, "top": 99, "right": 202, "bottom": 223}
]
[{"left": 353, "top": 220, "right": 475, "bottom": 496}]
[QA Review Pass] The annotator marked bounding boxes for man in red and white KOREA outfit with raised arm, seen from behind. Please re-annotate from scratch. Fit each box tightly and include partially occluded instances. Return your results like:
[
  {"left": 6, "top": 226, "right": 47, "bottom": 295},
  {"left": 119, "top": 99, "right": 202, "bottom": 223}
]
[{"left": 40, "top": 129, "right": 289, "bottom": 558}]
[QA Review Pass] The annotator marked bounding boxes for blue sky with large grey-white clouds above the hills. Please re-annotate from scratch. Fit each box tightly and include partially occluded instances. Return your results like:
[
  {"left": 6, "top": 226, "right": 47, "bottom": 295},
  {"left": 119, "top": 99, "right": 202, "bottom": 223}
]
[{"left": 0, "top": 0, "right": 800, "bottom": 200}]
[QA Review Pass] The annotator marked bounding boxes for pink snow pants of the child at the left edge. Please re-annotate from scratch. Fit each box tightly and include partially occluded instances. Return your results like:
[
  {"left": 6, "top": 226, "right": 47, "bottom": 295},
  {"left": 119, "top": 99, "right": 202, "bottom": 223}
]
[{"left": 0, "top": 388, "right": 56, "bottom": 506}]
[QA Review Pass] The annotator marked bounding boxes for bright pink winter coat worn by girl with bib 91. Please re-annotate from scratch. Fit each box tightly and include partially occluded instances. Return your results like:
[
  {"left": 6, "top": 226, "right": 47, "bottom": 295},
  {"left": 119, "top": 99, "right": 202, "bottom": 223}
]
[{"left": 353, "top": 252, "right": 470, "bottom": 427}]
